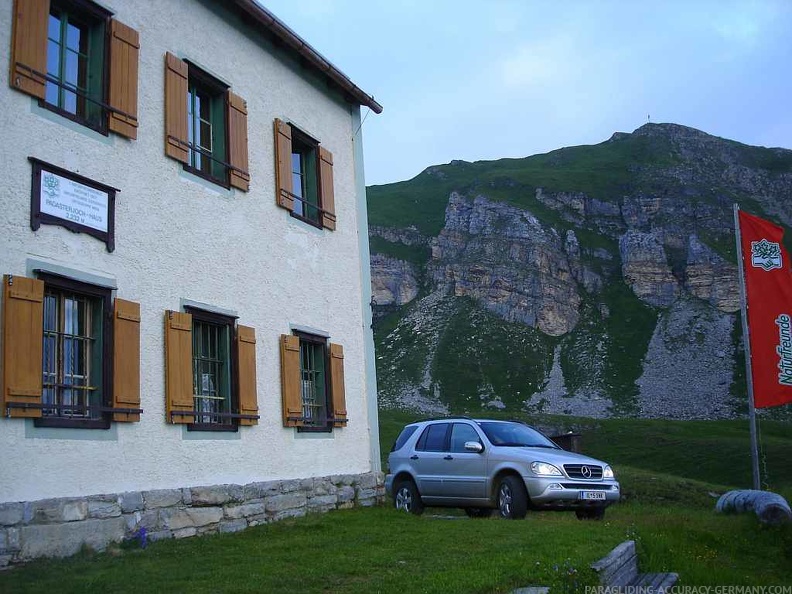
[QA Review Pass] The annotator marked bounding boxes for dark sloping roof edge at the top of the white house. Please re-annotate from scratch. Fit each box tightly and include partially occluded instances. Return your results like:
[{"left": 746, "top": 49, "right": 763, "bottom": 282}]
[{"left": 229, "top": 0, "right": 382, "bottom": 113}]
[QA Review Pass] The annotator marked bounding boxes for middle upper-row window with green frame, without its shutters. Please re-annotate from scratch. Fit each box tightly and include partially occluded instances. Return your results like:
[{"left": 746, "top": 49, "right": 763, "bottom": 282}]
[{"left": 185, "top": 64, "right": 228, "bottom": 185}]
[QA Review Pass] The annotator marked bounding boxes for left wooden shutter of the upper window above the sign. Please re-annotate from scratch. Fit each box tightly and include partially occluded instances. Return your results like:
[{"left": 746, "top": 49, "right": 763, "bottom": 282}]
[{"left": 8, "top": 0, "right": 49, "bottom": 99}]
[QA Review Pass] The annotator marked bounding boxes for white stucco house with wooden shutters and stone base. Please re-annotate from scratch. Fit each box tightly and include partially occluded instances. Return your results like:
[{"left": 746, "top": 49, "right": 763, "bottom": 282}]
[{"left": 0, "top": 0, "right": 381, "bottom": 564}]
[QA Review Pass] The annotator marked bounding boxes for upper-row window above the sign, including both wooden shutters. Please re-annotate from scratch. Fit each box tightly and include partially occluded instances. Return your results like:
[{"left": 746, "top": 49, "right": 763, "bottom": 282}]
[{"left": 10, "top": 0, "right": 140, "bottom": 138}]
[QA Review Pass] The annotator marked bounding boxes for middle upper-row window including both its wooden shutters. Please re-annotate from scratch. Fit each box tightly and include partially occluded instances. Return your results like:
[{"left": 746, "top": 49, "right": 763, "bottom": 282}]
[{"left": 165, "top": 53, "right": 250, "bottom": 191}]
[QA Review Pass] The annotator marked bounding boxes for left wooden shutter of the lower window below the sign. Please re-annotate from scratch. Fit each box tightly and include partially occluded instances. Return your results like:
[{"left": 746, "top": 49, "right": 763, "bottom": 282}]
[{"left": 0, "top": 274, "right": 44, "bottom": 417}]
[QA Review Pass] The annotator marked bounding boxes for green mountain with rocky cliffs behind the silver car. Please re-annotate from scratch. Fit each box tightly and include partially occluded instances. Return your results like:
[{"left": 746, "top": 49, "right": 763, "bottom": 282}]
[{"left": 368, "top": 124, "right": 792, "bottom": 418}]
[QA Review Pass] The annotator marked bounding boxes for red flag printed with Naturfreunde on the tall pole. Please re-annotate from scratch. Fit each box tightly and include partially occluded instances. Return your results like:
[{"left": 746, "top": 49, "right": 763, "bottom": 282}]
[{"left": 739, "top": 211, "right": 792, "bottom": 408}]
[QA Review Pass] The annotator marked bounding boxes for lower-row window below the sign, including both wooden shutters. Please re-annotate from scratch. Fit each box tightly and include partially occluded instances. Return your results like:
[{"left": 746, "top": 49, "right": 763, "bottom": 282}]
[{"left": 0, "top": 272, "right": 142, "bottom": 429}]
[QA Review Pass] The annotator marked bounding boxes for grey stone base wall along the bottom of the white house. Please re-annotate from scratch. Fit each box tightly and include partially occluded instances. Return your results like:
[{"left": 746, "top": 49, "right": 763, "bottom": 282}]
[{"left": 0, "top": 472, "right": 385, "bottom": 568}]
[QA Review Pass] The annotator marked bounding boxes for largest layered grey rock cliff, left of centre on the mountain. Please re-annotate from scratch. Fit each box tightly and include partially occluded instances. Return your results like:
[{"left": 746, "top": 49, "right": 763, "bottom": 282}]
[{"left": 428, "top": 192, "right": 582, "bottom": 336}]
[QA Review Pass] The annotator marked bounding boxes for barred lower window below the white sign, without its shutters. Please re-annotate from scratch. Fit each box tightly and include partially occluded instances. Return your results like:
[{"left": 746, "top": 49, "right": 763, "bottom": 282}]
[{"left": 36, "top": 275, "right": 111, "bottom": 427}]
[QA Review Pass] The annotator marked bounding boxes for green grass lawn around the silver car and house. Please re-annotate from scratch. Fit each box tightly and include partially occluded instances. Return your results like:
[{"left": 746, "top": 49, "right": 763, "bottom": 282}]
[{"left": 0, "top": 412, "right": 792, "bottom": 593}]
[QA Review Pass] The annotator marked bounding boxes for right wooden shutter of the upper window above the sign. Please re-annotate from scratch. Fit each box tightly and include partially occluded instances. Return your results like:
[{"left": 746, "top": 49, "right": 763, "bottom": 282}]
[{"left": 108, "top": 20, "right": 140, "bottom": 139}]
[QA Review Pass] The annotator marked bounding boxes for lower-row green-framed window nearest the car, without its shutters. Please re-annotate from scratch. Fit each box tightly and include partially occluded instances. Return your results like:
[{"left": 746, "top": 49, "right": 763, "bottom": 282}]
[{"left": 298, "top": 333, "right": 329, "bottom": 430}]
